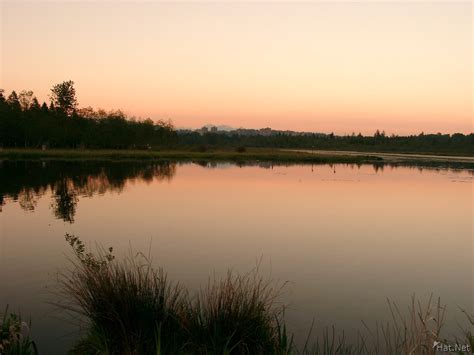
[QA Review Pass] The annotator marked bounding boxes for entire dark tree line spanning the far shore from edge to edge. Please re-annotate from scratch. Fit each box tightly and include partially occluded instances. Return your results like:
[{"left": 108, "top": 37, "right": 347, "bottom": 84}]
[{"left": 0, "top": 81, "right": 474, "bottom": 155}]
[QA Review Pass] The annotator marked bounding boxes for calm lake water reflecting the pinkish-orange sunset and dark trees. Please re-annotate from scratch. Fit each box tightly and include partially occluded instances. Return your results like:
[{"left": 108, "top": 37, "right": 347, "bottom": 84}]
[{"left": 0, "top": 161, "right": 474, "bottom": 354}]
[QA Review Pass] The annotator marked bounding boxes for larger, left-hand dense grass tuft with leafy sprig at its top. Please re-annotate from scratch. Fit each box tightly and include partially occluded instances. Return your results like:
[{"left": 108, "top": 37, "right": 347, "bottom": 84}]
[{"left": 60, "top": 235, "right": 186, "bottom": 354}]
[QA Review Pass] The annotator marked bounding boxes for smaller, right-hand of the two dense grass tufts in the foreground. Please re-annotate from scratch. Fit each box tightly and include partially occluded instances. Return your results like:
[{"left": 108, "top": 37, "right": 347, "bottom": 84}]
[{"left": 185, "top": 269, "right": 291, "bottom": 354}]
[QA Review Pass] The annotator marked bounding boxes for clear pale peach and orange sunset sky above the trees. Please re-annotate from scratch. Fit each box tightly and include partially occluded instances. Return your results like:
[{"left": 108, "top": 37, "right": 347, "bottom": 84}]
[{"left": 0, "top": 0, "right": 474, "bottom": 134}]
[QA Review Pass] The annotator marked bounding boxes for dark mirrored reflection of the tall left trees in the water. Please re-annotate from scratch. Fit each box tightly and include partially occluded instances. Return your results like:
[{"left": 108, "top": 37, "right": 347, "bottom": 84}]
[{"left": 0, "top": 161, "right": 176, "bottom": 223}]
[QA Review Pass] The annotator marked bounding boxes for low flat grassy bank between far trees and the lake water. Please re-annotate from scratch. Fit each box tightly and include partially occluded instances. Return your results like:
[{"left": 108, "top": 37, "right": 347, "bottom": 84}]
[{"left": 0, "top": 148, "right": 474, "bottom": 168}]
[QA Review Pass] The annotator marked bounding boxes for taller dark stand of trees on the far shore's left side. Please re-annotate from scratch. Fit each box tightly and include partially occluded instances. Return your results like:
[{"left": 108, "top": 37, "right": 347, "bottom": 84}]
[{"left": 0, "top": 81, "right": 176, "bottom": 149}]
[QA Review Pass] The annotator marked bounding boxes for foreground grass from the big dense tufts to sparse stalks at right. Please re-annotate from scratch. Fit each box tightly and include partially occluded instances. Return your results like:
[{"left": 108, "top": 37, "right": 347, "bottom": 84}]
[{"left": 53, "top": 235, "right": 473, "bottom": 355}]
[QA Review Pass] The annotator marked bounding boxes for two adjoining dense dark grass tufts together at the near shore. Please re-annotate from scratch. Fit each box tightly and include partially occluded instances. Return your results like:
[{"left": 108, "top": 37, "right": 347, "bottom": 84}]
[{"left": 59, "top": 234, "right": 289, "bottom": 354}]
